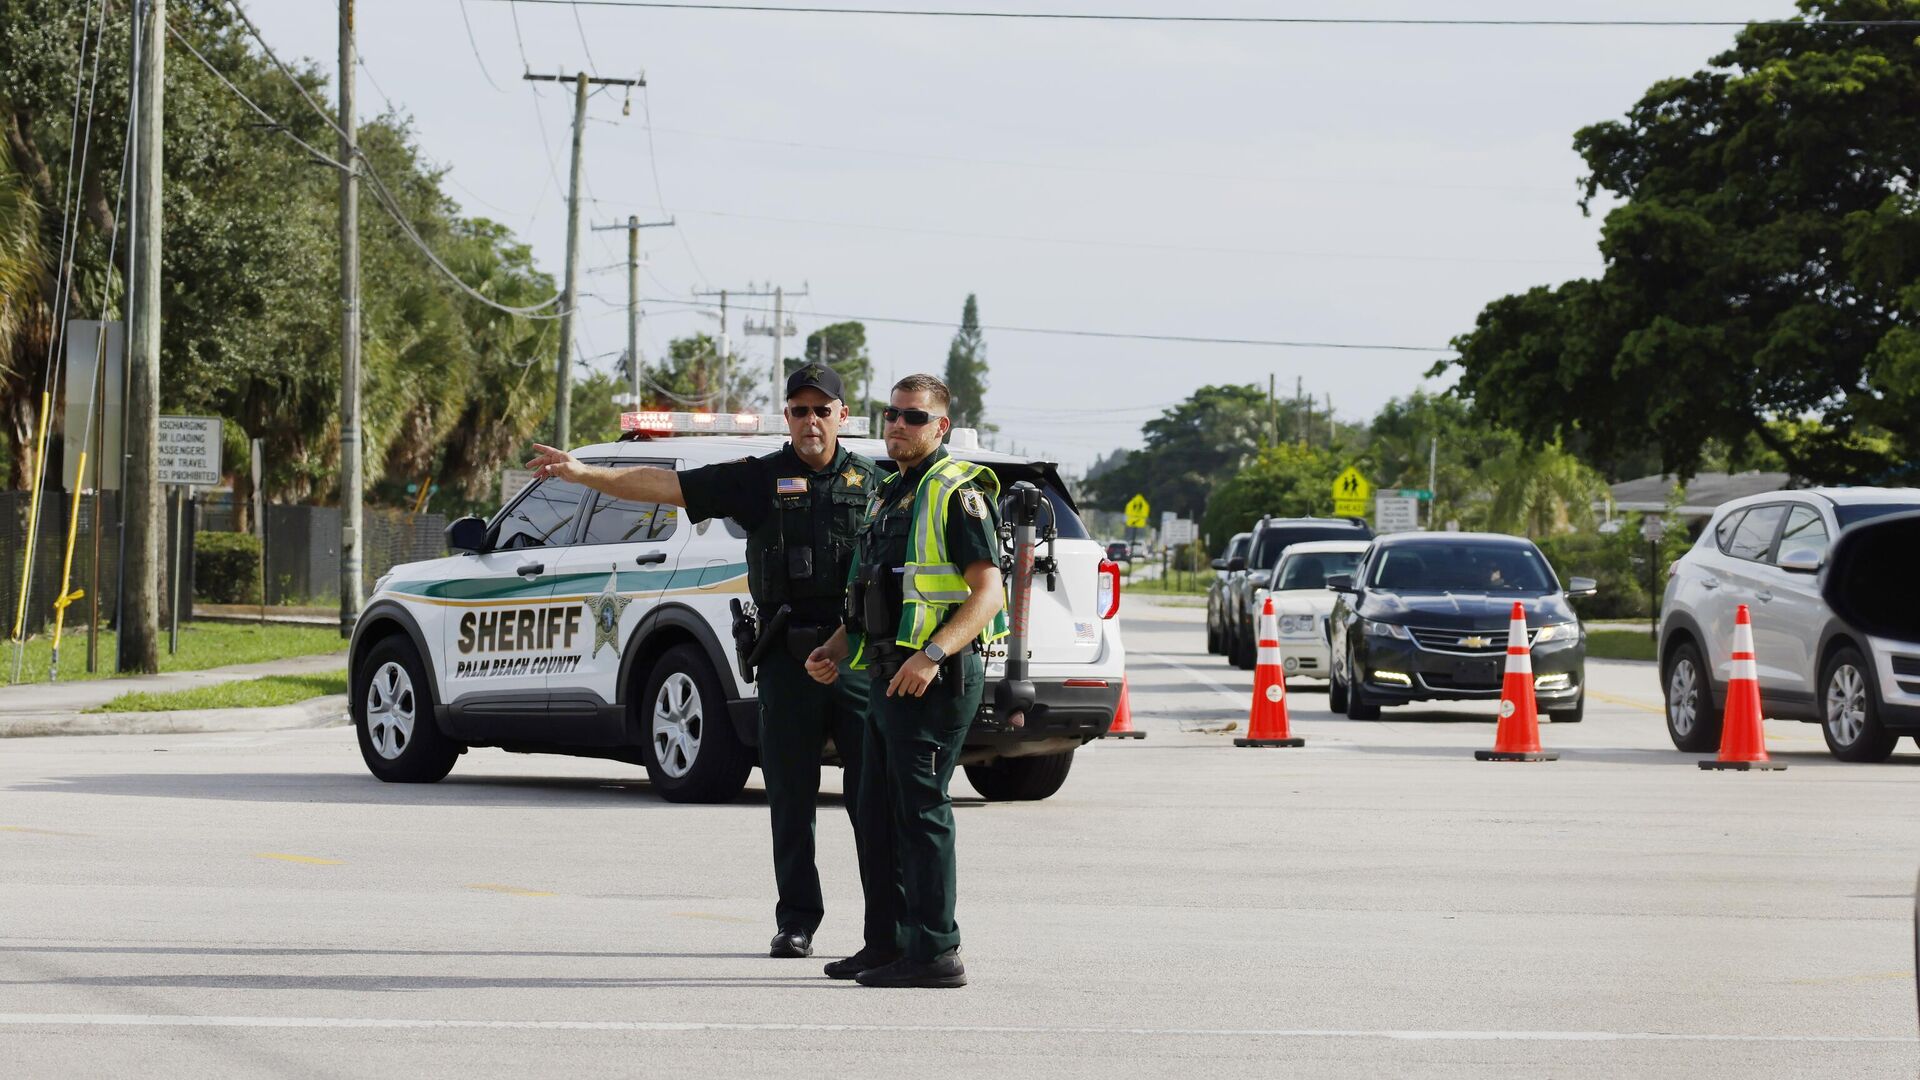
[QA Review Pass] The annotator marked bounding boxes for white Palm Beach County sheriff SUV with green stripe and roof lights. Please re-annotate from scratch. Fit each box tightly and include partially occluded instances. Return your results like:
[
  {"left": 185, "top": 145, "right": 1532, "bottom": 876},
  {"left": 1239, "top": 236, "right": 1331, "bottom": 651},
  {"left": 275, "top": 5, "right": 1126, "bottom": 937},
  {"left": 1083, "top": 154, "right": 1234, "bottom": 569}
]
[{"left": 348, "top": 413, "right": 1125, "bottom": 801}]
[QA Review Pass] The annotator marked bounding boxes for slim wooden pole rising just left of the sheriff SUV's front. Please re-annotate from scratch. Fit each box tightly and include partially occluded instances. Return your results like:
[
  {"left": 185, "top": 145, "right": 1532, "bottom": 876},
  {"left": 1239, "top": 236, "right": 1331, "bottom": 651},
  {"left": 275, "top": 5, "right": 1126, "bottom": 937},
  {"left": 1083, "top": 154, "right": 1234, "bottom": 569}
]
[{"left": 340, "top": 0, "right": 365, "bottom": 638}]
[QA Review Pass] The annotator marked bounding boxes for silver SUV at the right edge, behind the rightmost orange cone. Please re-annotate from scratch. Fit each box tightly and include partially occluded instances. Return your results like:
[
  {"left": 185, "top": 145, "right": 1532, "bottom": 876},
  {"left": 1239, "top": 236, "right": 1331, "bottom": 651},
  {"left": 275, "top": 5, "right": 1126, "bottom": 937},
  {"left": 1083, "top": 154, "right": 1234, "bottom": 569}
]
[{"left": 1659, "top": 488, "right": 1920, "bottom": 761}]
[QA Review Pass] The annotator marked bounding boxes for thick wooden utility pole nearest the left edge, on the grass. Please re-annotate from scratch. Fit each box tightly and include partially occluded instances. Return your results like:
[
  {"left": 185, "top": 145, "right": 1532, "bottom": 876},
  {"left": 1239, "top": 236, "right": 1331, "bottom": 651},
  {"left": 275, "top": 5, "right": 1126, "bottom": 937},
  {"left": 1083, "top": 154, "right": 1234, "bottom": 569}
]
[{"left": 119, "top": 0, "right": 167, "bottom": 673}]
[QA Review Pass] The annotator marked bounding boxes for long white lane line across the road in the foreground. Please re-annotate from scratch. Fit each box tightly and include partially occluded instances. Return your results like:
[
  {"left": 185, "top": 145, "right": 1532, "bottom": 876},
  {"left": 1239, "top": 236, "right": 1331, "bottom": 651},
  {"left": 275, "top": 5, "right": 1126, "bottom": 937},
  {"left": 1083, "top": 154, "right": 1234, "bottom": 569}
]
[{"left": 0, "top": 1013, "right": 1920, "bottom": 1043}]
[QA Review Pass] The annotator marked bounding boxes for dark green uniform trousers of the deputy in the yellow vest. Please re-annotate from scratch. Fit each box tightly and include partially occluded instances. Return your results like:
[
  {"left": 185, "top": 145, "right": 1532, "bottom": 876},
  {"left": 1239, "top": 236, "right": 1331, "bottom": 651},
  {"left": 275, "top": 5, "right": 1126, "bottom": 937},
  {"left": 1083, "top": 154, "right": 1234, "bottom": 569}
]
[{"left": 860, "top": 650, "right": 987, "bottom": 961}]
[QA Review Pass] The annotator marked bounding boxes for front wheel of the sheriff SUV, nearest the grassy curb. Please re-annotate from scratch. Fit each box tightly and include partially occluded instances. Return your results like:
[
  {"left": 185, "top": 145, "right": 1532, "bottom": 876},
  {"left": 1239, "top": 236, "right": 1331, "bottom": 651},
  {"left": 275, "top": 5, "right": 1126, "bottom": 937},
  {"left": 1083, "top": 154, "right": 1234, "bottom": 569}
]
[{"left": 348, "top": 634, "right": 461, "bottom": 784}]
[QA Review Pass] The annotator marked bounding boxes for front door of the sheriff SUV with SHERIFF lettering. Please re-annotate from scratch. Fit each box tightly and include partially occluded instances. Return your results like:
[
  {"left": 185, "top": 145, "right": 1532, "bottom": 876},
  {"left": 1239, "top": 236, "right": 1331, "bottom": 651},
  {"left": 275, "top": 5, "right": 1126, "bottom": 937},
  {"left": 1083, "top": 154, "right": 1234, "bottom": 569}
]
[{"left": 440, "top": 472, "right": 586, "bottom": 742}]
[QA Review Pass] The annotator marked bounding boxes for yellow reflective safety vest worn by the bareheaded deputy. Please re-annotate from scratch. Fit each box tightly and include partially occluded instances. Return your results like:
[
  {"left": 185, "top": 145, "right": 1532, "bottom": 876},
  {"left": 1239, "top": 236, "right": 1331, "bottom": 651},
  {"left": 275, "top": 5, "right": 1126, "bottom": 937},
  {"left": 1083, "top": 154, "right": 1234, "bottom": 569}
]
[{"left": 847, "top": 457, "right": 1006, "bottom": 671}]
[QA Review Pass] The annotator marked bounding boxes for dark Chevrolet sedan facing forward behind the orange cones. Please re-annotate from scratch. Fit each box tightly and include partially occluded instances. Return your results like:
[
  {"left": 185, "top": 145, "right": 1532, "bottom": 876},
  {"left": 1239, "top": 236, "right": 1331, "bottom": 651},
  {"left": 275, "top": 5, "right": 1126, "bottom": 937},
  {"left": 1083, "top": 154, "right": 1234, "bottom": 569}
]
[{"left": 1327, "top": 532, "right": 1594, "bottom": 723}]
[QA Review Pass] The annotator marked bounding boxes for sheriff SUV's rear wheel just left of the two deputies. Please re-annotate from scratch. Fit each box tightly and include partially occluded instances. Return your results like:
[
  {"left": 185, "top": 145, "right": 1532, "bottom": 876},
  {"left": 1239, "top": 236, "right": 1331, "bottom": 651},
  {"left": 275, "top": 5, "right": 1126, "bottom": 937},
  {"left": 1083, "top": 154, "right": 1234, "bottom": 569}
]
[{"left": 634, "top": 644, "right": 753, "bottom": 803}]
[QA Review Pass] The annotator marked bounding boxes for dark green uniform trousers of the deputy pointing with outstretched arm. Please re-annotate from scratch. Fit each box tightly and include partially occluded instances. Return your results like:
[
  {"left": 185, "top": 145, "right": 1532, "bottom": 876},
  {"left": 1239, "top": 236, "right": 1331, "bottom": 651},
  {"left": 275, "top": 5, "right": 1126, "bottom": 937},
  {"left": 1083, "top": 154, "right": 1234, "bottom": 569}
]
[{"left": 758, "top": 648, "right": 893, "bottom": 947}]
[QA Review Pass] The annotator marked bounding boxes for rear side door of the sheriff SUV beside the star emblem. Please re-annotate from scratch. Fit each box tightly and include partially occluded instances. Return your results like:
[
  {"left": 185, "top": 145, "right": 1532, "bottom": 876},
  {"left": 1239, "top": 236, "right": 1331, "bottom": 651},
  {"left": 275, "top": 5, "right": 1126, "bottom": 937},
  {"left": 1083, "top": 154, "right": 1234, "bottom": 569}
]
[{"left": 547, "top": 459, "right": 689, "bottom": 746}]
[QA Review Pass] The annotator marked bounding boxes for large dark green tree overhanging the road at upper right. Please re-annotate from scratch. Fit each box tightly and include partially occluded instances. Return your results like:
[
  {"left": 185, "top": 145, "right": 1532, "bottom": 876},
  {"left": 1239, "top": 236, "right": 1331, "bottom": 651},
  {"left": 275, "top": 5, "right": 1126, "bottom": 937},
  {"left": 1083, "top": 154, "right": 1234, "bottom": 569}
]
[{"left": 1453, "top": 0, "right": 1920, "bottom": 480}]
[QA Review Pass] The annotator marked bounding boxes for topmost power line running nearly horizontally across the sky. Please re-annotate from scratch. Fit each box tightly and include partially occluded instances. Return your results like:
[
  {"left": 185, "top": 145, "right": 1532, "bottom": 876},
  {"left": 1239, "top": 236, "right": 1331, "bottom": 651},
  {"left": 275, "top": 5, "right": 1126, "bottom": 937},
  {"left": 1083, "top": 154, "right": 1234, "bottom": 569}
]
[{"left": 464, "top": 0, "right": 1920, "bottom": 29}]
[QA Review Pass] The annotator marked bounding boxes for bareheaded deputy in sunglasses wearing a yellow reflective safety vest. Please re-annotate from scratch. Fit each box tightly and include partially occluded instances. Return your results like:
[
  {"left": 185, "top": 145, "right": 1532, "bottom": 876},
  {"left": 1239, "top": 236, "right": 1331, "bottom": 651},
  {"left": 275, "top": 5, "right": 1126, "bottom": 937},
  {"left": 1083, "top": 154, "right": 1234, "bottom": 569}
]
[{"left": 806, "top": 375, "right": 1006, "bottom": 986}]
